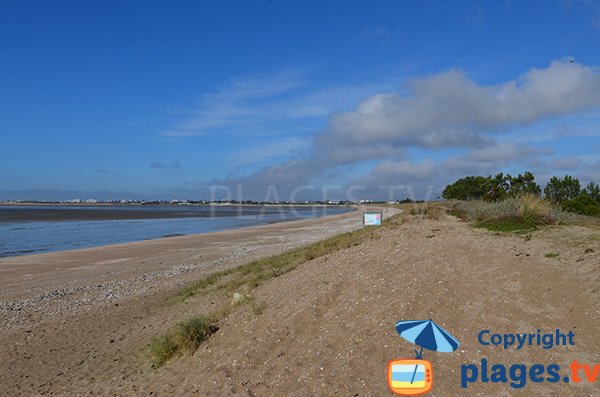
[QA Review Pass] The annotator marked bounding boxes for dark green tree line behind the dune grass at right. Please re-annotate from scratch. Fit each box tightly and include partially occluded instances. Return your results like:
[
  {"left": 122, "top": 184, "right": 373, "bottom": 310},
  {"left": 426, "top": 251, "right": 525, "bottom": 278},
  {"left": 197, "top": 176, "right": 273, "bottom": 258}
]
[{"left": 442, "top": 171, "right": 600, "bottom": 216}]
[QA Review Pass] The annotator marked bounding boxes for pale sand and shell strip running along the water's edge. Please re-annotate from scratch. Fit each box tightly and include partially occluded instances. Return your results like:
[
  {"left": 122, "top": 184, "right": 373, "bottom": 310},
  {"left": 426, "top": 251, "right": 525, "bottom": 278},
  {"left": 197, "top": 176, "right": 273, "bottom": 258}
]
[{"left": 0, "top": 206, "right": 393, "bottom": 302}]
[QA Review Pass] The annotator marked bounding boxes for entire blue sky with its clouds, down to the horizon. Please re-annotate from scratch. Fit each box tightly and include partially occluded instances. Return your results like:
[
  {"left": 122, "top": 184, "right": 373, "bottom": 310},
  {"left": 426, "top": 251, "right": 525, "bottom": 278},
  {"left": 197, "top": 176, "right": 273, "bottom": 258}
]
[{"left": 0, "top": 0, "right": 600, "bottom": 199}]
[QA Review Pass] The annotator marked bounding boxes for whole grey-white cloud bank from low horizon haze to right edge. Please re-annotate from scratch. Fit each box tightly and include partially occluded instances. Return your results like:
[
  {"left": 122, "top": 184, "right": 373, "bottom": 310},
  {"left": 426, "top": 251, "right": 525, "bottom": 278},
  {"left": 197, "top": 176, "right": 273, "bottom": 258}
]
[{"left": 218, "top": 60, "right": 600, "bottom": 200}]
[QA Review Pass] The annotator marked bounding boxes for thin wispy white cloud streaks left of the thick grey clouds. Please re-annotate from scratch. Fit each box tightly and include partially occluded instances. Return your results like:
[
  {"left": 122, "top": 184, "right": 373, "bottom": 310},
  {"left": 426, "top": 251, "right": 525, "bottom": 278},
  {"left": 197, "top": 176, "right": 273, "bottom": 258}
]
[{"left": 160, "top": 70, "right": 397, "bottom": 138}]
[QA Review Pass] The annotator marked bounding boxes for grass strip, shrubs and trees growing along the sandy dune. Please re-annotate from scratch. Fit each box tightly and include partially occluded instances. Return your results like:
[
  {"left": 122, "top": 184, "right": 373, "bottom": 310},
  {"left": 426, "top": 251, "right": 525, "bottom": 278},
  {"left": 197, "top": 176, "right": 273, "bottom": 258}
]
[{"left": 147, "top": 182, "right": 600, "bottom": 368}]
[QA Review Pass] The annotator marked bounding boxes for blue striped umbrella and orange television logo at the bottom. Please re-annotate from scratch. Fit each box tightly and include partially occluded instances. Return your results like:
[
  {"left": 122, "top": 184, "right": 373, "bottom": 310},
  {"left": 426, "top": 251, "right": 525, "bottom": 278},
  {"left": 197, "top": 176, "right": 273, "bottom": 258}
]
[{"left": 387, "top": 320, "right": 460, "bottom": 396}]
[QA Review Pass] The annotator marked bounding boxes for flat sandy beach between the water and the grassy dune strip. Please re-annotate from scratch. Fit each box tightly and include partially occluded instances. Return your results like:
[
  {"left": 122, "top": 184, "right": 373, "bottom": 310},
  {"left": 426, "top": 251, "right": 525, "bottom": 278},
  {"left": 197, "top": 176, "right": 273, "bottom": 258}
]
[{"left": 0, "top": 206, "right": 380, "bottom": 396}]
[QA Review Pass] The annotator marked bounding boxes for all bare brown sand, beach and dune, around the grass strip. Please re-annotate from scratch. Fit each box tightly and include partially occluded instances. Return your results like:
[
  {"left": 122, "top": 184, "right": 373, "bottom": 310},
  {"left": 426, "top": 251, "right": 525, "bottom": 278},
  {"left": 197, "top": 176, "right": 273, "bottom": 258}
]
[{"left": 0, "top": 209, "right": 600, "bottom": 396}]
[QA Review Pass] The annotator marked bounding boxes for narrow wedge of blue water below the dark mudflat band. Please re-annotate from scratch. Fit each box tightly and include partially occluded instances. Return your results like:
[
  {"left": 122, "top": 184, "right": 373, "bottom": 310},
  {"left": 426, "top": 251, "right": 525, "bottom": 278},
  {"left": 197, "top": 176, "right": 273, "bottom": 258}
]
[{"left": 0, "top": 207, "right": 351, "bottom": 257}]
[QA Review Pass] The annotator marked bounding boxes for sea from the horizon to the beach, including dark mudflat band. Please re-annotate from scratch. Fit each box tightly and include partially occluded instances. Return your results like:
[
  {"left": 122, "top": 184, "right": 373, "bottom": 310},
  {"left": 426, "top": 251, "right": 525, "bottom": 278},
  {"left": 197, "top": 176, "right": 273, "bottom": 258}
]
[{"left": 0, "top": 206, "right": 352, "bottom": 257}]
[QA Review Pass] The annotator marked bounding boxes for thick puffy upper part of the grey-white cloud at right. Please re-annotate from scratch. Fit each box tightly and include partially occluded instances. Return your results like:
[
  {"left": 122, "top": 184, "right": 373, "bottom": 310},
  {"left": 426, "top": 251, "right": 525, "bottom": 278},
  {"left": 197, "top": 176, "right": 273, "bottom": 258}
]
[{"left": 322, "top": 62, "right": 600, "bottom": 152}]
